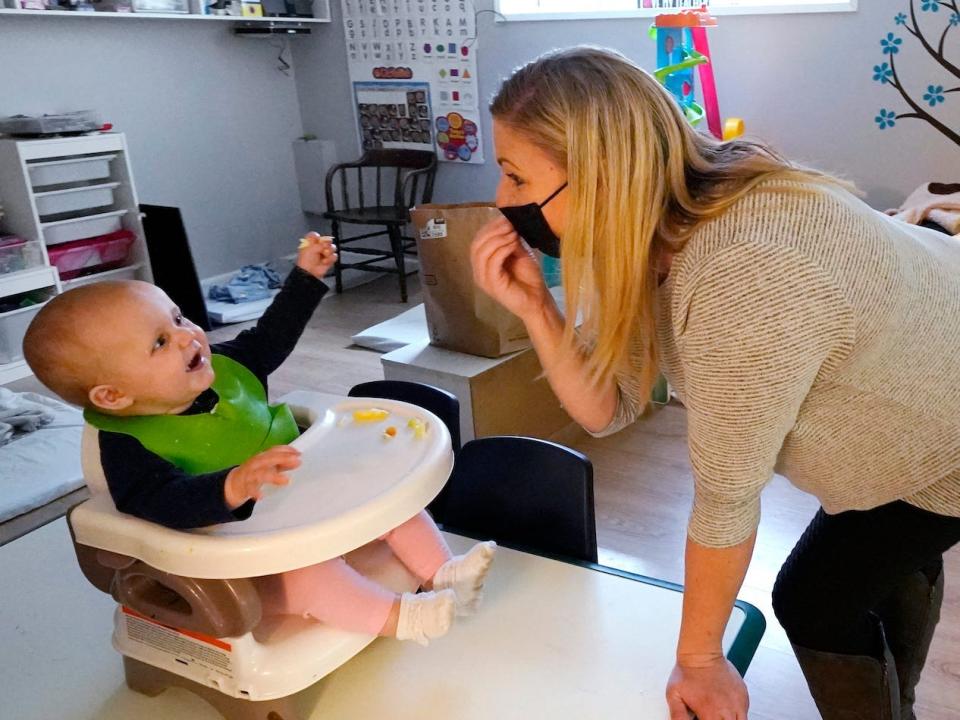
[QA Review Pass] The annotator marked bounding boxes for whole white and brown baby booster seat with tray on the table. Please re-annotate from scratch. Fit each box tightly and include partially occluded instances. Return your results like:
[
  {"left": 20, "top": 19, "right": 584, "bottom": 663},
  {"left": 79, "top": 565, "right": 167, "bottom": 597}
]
[{"left": 68, "top": 393, "right": 453, "bottom": 720}]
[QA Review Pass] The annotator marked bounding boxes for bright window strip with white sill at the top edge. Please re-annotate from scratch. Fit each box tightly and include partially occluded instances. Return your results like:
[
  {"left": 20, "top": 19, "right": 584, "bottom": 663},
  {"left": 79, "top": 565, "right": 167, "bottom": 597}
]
[{"left": 497, "top": 0, "right": 857, "bottom": 20}]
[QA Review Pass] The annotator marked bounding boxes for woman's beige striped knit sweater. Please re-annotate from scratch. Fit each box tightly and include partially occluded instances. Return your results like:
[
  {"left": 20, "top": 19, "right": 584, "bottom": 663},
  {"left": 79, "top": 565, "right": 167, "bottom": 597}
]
[{"left": 598, "top": 181, "right": 960, "bottom": 547}]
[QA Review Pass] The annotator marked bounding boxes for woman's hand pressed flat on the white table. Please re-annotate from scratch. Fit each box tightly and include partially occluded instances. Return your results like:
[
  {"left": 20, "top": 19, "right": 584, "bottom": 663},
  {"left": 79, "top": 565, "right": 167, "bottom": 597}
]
[{"left": 667, "top": 655, "right": 750, "bottom": 720}]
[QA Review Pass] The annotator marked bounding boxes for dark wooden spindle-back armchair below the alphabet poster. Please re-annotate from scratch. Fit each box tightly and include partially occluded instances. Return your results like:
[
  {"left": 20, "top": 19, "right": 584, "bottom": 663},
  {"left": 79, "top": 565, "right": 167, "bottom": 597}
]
[{"left": 324, "top": 149, "right": 437, "bottom": 302}]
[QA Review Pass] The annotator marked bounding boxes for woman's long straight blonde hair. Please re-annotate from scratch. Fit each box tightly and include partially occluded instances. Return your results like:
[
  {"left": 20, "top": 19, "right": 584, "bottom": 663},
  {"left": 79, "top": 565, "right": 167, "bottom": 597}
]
[{"left": 490, "top": 46, "right": 834, "bottom": 398}]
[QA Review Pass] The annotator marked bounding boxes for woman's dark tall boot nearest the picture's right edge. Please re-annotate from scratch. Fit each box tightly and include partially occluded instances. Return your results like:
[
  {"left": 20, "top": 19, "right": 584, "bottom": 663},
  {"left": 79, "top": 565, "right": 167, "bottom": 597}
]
[{"left": 877, "top": 560, "right": 943, "bottom": 720}]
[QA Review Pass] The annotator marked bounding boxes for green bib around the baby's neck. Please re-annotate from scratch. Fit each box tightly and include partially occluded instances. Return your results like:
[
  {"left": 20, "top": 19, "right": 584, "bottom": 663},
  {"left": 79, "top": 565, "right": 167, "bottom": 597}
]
[{"left": 83, "top": 355, "right": 300, "bottom": 475}]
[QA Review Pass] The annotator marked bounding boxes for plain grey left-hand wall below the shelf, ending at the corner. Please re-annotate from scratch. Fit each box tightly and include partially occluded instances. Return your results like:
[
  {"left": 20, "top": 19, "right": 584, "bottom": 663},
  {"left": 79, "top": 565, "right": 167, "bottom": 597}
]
[{"left": 0, "top": 16, "right": 305, "bottom": 277}]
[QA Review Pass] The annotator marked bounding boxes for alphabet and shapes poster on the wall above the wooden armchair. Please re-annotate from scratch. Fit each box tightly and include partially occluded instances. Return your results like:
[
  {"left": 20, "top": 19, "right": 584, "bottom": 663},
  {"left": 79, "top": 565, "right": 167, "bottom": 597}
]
[{"left": 340, "top": 0, "right": 483, "bottom": 163}]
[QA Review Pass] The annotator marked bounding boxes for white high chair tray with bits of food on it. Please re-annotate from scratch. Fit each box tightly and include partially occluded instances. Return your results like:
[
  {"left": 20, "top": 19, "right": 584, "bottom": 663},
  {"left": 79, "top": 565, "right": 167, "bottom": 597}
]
[{"left": 71, "top": 392, "right": 453, "bottom": 578}]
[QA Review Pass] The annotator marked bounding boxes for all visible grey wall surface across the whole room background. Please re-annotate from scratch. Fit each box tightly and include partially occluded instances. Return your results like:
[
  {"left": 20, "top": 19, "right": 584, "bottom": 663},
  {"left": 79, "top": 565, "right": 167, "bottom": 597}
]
[{"left": 0, "top": 0, "right": 960, "bottom": 284}]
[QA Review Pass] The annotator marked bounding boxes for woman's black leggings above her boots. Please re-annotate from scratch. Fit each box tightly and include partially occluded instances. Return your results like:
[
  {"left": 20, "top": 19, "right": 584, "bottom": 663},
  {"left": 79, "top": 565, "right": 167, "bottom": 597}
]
[{"left": 773, "top": 501, "right": 960, "bottom": 655}]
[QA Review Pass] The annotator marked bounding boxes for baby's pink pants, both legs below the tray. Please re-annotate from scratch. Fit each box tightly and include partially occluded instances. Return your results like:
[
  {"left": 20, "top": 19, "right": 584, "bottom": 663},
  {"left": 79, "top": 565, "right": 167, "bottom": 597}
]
[{"left": 258, "top": 511, "right": 451, "bottom": 635}]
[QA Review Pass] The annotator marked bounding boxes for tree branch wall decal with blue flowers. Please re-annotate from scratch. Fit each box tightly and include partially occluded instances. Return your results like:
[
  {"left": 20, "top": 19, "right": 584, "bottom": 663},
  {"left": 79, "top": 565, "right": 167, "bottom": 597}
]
[{"left": 873, "top": 0, "right": 960, "bottom": 145}]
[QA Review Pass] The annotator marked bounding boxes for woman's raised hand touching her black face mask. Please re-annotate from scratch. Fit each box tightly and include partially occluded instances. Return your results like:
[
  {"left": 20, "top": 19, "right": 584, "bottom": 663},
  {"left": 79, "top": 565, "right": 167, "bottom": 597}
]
[{"left": 470, "top": 217, "right": 550, "bottom": 319}]
